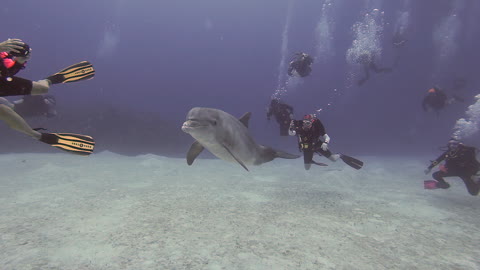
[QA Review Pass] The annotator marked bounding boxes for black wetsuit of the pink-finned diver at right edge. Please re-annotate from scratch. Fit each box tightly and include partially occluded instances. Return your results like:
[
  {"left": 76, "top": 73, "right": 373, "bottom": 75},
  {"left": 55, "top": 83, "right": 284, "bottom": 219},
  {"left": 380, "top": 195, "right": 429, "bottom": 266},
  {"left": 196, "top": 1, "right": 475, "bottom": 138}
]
[{"left": 428, "top": 144, "right": 480, "bottom": 196}]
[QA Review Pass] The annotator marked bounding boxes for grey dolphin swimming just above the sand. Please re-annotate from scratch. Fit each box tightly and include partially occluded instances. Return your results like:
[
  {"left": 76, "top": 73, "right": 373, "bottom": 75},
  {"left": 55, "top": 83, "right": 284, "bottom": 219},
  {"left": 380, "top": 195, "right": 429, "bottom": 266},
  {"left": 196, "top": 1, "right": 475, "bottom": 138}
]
[{"left": 182, "top": 107, "right": 300, "bottom": 171}]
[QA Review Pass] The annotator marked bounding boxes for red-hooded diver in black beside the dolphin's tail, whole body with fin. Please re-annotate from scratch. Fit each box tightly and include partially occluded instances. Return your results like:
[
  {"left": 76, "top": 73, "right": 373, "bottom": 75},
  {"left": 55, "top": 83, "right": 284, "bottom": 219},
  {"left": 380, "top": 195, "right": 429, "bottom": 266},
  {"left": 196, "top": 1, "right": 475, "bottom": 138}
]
[{"left": 288, "top": 114, "right": 363, "bottom": 170}]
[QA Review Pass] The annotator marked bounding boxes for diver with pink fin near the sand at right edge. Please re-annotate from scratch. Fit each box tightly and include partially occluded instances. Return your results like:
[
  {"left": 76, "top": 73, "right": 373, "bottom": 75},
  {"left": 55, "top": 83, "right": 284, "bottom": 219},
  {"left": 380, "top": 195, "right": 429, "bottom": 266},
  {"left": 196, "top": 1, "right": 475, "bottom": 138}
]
[{"left": 424, "top": 139, "right": 480, "bottom": 196}]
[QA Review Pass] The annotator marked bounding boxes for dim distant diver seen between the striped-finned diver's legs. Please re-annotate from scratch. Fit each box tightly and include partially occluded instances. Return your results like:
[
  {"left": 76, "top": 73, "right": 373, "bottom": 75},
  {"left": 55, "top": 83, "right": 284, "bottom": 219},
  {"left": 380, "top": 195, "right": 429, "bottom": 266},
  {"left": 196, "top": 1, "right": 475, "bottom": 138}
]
[{"left": 0, "top": 95, "right": 57, "bottom": 118}]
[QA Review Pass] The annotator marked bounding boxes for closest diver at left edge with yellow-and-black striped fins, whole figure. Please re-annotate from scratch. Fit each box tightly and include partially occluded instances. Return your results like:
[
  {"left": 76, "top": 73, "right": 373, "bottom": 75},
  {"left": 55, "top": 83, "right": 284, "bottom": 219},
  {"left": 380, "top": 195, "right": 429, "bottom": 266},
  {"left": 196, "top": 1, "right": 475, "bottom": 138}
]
[{"left": 0, "top": 39, "right": 95, "bottom": 155}]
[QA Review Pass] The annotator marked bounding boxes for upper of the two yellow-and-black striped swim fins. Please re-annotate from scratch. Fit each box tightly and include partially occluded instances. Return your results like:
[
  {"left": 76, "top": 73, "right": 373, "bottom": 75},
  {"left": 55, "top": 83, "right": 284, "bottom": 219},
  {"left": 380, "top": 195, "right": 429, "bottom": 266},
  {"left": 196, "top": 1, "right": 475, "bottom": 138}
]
[{"left": 47, "top": 61, "right": 95, "bottom": 84}]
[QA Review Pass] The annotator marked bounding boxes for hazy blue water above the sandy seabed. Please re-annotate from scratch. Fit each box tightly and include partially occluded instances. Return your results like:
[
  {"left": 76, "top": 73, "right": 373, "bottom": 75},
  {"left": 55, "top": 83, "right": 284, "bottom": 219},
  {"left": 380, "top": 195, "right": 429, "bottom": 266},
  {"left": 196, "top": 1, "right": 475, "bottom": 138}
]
[{"left": 0, "top": 0, "right": 480, "bottom": 155}]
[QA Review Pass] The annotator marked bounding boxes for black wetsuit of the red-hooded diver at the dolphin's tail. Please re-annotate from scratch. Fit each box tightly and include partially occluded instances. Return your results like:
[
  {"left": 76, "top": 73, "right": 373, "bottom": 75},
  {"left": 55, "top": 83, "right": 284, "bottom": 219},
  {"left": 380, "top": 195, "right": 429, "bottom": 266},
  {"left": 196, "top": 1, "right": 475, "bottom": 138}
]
[{"left": 293, "top": 118, "right": 332, "bottom": 164}]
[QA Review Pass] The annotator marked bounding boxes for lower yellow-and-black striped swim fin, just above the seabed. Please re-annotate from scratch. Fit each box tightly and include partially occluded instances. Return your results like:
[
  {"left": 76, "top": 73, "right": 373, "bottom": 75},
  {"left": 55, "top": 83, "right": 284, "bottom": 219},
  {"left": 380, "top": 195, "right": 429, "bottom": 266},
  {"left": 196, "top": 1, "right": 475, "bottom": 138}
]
[{"left": 40, "top": 133, "right": 95, "bottom": 156}]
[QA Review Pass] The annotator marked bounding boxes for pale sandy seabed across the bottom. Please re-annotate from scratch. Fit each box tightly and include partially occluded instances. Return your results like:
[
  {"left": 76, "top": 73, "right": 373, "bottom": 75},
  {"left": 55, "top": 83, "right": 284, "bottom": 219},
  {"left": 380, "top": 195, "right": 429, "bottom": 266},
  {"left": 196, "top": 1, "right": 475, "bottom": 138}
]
[{"left": 0, "top": 152, "right": 480, "bottom": 270}]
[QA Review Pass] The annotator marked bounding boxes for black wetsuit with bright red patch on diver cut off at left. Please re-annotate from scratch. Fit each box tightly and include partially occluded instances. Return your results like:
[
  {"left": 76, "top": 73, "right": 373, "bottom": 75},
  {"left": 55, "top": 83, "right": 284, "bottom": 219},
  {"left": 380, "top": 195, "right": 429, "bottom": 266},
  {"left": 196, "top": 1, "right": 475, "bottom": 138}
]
[{"left": 0, "top": 52, "right": 33, "bottom": 97}]
